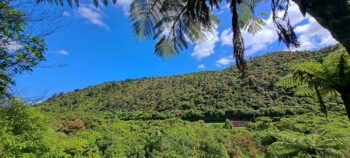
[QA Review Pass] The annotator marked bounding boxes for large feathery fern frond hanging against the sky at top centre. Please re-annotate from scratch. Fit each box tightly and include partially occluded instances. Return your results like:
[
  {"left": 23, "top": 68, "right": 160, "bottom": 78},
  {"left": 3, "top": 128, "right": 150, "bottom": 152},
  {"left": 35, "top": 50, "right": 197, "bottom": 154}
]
[{"left": 129, "top": 0, "right": 219, "bottom": 58}]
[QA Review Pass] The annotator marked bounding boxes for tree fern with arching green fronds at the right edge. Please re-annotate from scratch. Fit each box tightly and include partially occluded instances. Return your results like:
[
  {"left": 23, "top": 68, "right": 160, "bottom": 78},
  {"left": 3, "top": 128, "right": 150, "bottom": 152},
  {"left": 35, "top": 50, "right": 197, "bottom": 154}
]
[{"left": 278, "top": 50, "right": 350, "bottom": 120}]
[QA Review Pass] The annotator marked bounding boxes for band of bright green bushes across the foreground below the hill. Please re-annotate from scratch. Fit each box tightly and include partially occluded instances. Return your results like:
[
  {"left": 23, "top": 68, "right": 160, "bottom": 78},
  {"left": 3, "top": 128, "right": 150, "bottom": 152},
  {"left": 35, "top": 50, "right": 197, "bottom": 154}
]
[{"left": 0, "top": 100, "right": 350, "bottom": 158}]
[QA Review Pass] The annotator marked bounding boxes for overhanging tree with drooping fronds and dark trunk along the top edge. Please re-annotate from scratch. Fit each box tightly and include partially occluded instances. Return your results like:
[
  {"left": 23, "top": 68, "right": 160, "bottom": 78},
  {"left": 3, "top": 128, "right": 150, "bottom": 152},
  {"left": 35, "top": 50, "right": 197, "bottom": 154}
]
[{"left": 37, "top": 0, "right": 350, "bottom": 76}]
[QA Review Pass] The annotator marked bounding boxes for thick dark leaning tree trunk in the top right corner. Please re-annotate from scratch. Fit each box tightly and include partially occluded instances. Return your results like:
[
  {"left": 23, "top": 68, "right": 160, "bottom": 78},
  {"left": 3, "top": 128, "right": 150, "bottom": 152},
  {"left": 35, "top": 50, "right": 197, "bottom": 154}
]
[{"left": 293, "top": 0, "right": 350, "bottom": 53}]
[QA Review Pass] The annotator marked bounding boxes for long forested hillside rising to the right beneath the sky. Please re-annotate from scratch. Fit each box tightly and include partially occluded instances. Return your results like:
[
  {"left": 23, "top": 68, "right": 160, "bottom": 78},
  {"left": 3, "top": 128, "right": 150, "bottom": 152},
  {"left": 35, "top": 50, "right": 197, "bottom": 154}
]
[{"left": 38, "top": 45, "right": 343, "bottom": 121}]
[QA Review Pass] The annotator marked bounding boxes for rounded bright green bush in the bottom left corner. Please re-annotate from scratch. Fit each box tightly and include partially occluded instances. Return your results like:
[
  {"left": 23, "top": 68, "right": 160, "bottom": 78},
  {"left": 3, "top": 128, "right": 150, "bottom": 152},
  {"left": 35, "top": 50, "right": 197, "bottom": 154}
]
[{"left": 0, "top": 100, "right": 50, "bottom": 157}]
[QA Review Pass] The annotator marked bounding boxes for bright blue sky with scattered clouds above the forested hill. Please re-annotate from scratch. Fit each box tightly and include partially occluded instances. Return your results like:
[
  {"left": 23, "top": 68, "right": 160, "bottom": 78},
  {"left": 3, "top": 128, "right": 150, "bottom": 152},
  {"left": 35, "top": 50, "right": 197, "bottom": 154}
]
[{"left": 13, "top": 0, "right": 336, "bottom": 100}]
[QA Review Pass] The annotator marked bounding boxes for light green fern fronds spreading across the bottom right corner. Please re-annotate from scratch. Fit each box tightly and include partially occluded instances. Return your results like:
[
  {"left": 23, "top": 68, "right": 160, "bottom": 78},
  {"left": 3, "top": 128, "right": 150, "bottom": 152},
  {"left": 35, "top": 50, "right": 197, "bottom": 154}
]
[{"left": 247, "top": 113, "right": 350, "bottom": 157}]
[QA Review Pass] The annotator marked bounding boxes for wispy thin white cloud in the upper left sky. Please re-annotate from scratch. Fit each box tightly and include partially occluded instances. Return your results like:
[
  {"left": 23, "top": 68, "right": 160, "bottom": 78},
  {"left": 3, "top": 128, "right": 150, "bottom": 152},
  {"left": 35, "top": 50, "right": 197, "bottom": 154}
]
[{"left": 75, "top": 5, "right": 110, "bottom": 30}]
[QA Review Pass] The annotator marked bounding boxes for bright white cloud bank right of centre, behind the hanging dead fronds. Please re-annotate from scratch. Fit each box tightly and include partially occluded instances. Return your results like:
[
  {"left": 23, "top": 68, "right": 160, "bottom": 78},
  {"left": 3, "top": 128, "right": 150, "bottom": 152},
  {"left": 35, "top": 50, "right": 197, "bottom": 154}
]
[{"left": 220, "top": 3, "right": 336, "bottom": 56}]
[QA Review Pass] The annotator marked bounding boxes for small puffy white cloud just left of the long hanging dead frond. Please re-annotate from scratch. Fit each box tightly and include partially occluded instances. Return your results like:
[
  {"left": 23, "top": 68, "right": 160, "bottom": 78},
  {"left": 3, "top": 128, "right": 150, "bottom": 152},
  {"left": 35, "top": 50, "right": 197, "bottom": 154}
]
[{"left": 191, "top": 29, "right": 219, "bottom": 60}]
